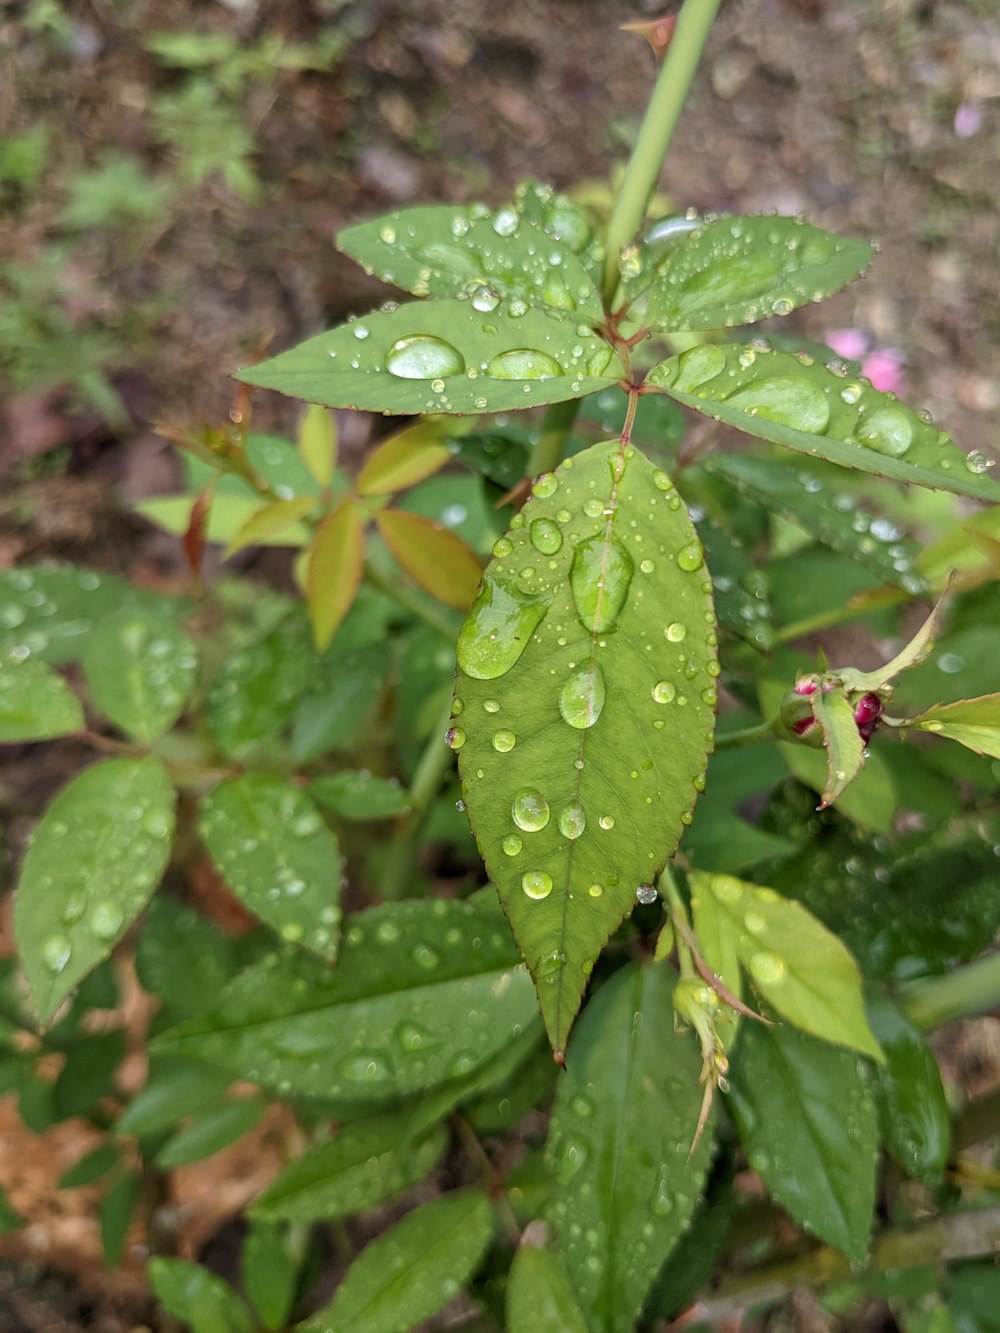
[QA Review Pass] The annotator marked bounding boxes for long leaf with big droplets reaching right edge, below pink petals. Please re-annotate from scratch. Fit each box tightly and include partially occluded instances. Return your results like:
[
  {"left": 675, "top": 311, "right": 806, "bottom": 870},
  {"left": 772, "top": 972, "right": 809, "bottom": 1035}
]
[{"left": 645, "top": 344, "right": 1000, "bottom": 501}]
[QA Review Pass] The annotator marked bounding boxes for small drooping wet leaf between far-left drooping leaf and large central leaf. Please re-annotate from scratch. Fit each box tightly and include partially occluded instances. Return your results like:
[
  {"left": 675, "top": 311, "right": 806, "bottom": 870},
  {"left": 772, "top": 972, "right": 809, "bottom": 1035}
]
[{"left": 199, "top": 773, "right": 343, "bottom": 960}]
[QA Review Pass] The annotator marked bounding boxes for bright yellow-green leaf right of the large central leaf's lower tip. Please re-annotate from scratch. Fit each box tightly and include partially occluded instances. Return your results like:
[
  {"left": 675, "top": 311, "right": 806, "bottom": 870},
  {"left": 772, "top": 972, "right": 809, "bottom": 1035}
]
[{"left": 688, "top": 870, "right": 883, "bottom": 1060}]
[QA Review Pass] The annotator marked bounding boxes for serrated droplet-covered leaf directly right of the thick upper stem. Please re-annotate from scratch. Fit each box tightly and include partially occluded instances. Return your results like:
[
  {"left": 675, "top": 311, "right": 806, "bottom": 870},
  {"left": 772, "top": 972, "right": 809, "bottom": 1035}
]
[{"left": 644, "top": 217, "right": 872, "bottom": 332}]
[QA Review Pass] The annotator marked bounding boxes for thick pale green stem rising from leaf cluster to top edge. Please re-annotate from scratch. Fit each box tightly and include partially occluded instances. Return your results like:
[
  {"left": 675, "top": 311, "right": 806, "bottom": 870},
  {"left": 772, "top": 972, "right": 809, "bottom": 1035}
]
[{"left": 603, "top": 0, "right": 720, "bottom": 305}]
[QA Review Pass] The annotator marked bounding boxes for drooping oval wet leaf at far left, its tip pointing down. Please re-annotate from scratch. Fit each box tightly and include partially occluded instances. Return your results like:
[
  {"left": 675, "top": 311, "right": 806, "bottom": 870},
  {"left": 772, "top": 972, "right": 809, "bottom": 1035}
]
[{"left": 15, "top": 757, "right": 175, "bottom": 1022}]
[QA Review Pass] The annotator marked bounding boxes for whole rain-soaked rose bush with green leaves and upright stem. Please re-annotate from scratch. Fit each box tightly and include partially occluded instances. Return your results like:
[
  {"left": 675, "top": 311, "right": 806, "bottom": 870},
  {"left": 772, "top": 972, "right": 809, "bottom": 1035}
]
[{"left": 0, "top": 0, "right": 1000, "bottom": 1333}]
